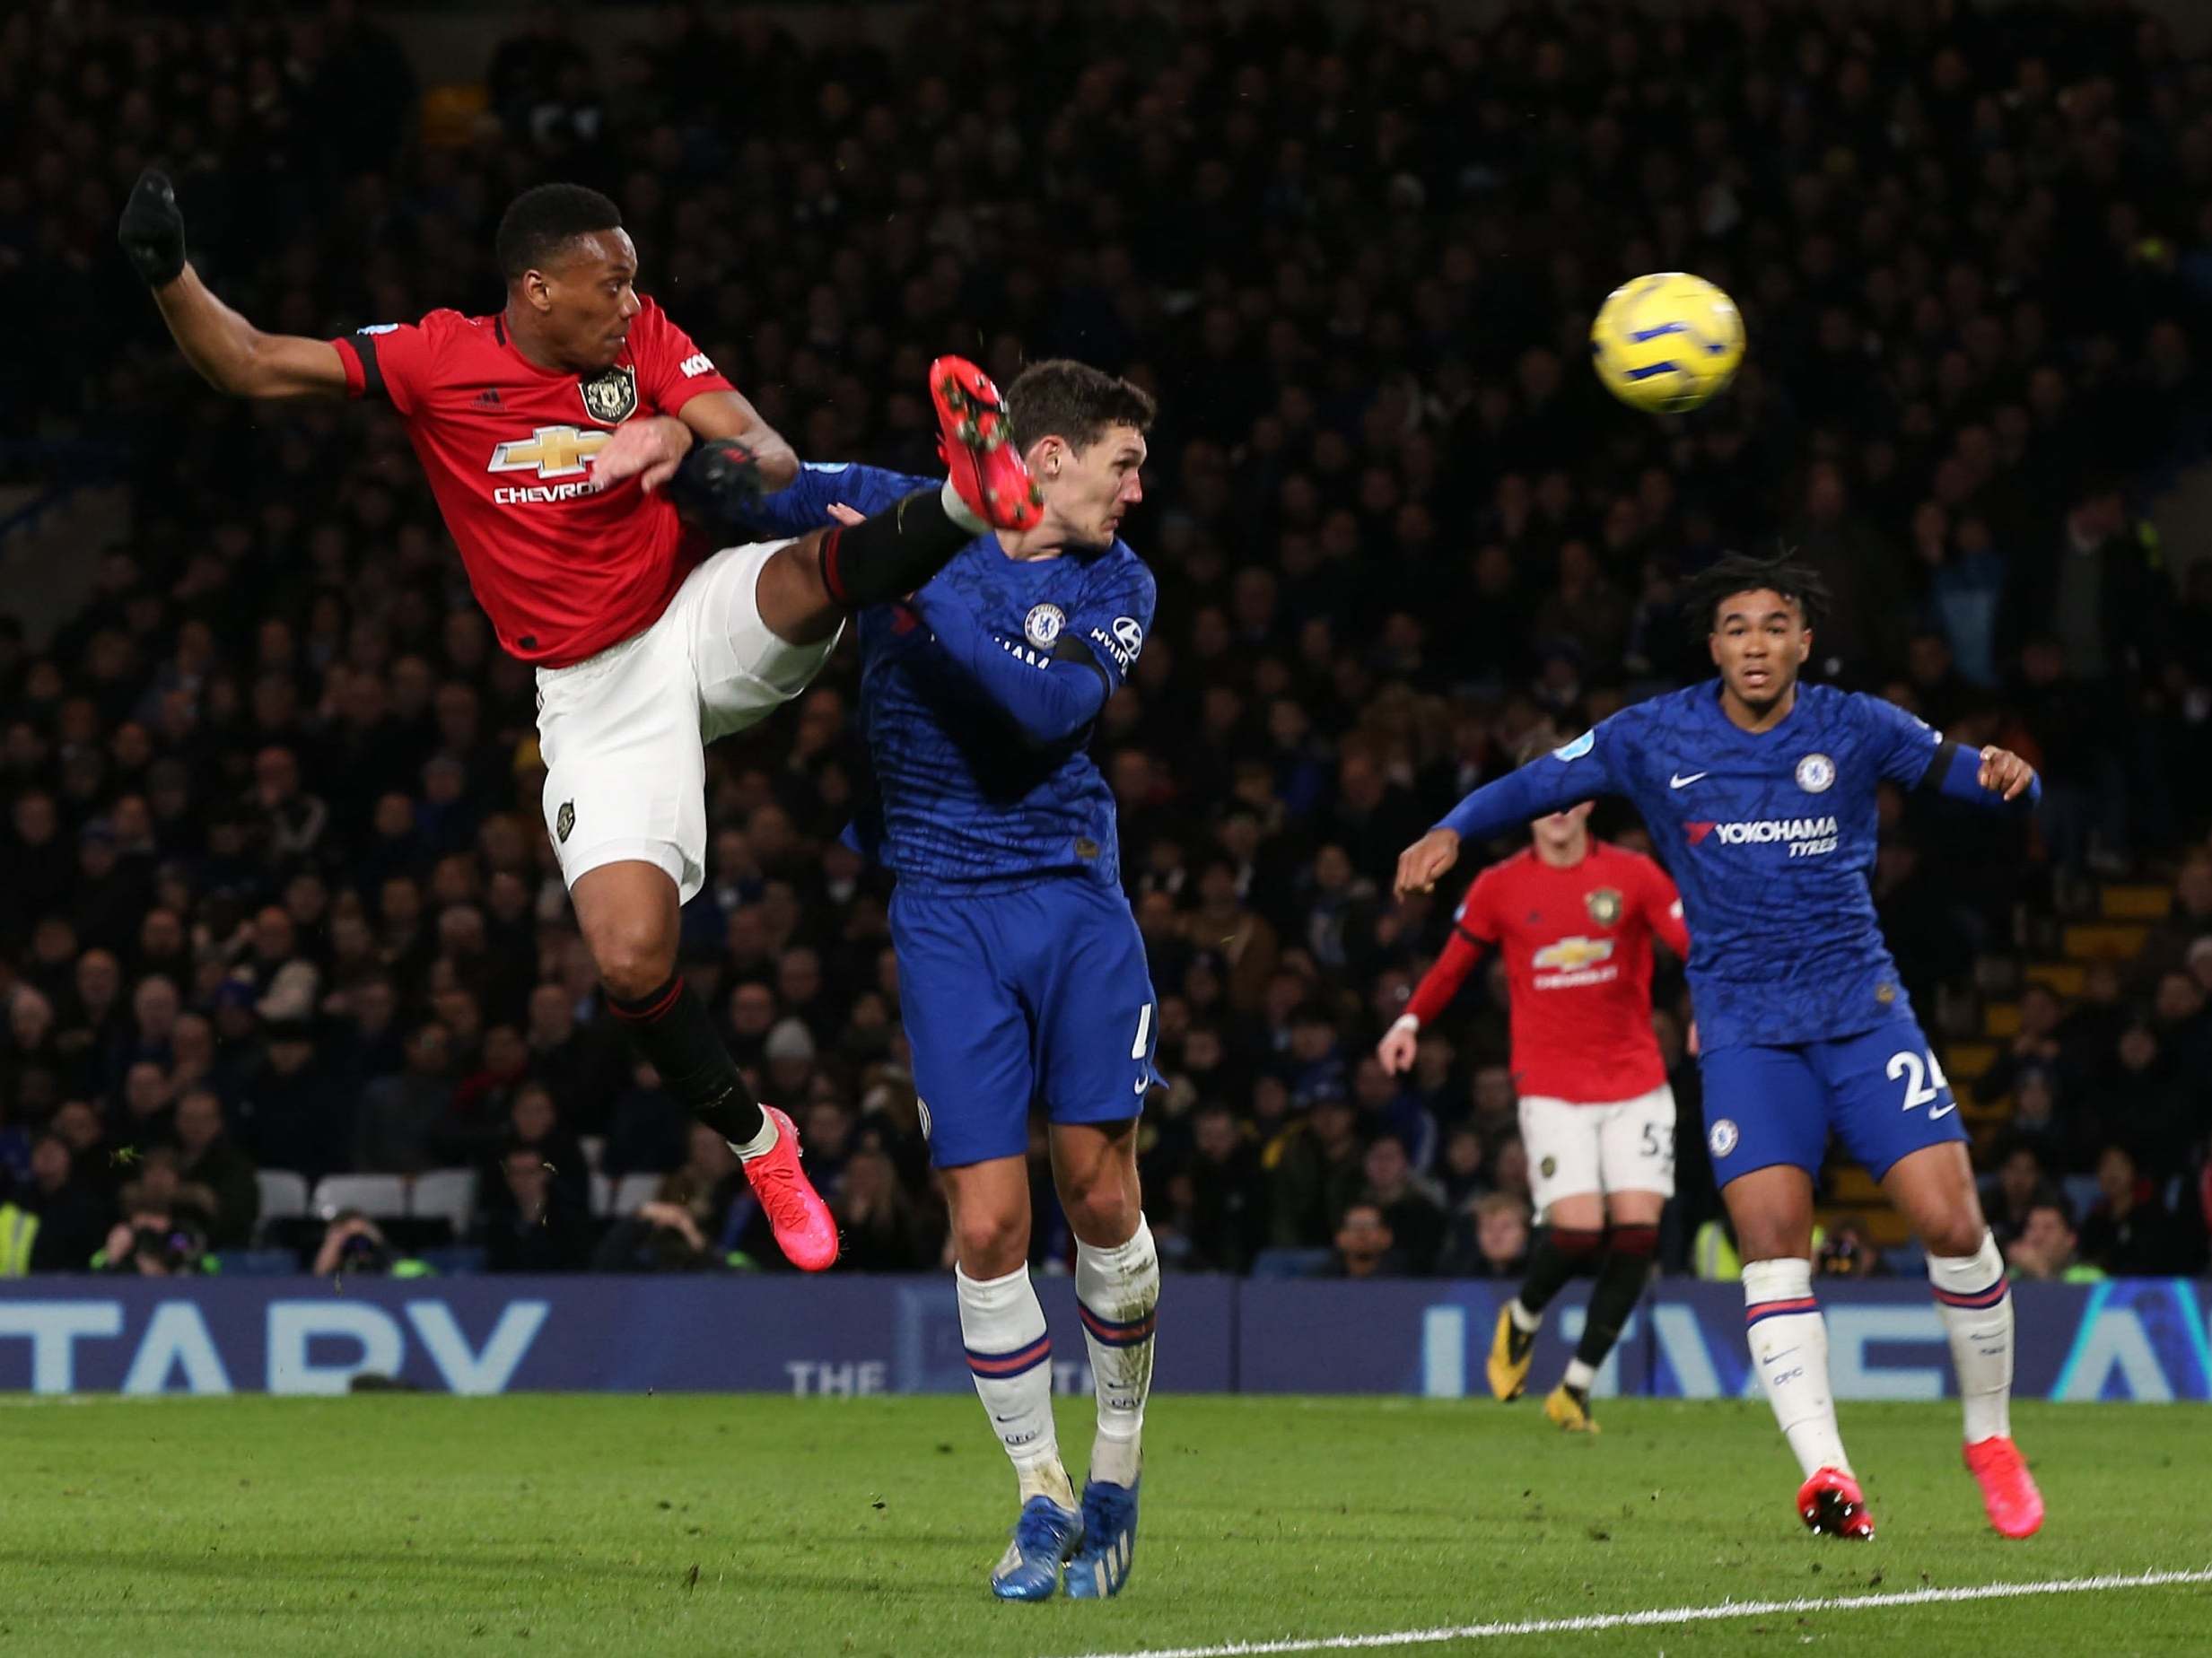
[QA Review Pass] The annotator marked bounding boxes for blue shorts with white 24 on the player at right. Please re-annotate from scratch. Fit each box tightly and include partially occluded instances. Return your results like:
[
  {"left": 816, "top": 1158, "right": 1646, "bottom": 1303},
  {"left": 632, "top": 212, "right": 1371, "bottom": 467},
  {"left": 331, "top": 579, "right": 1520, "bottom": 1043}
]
[{"left": 1699, "top": 1013, "right": 1966, "bottom": 1185}]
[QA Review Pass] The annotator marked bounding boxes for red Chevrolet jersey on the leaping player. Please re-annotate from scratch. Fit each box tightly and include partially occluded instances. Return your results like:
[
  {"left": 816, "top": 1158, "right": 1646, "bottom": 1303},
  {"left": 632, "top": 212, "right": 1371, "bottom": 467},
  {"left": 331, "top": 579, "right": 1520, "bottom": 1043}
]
[{"left": 332, "top": 299, "right": 730, "bottom": 668}]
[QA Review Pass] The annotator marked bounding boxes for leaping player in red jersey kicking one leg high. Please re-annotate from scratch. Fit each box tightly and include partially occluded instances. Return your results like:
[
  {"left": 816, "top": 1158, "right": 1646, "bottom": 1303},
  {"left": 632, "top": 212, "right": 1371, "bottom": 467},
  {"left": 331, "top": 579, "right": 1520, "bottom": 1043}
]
[{"left": 118, "top": 170, "right": 1042, "bottom": 1271}]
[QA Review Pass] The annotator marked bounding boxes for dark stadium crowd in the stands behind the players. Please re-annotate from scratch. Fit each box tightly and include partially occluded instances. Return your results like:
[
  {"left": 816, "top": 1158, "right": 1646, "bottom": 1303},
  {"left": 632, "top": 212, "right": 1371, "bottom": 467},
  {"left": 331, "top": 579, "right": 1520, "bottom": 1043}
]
[{"left": 0, "top": 0, "right": 2212, "bottom": 1276}]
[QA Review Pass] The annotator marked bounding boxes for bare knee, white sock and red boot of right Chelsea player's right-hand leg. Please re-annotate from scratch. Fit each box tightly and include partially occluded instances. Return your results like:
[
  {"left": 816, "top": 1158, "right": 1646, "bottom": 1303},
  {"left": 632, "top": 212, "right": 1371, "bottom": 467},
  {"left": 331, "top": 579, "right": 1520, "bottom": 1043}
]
[{"left": 1883, "top": 1143, "right": 2044, "bottom": 1536}]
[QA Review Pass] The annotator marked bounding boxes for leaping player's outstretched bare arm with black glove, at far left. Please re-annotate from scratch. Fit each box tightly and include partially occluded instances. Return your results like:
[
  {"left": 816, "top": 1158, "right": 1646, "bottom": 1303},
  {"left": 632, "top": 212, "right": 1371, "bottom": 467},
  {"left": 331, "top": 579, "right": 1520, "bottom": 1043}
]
[{"left": 115, "top": 168, "right": 345, "bottom": 398}]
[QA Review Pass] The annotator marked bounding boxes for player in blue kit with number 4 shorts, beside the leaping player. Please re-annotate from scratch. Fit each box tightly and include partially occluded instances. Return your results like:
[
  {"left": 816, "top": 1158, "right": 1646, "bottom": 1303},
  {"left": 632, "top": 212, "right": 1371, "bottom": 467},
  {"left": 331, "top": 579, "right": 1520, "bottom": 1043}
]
[{"left": 752, "top": 362, "right": 1159, "bottom": 1601}]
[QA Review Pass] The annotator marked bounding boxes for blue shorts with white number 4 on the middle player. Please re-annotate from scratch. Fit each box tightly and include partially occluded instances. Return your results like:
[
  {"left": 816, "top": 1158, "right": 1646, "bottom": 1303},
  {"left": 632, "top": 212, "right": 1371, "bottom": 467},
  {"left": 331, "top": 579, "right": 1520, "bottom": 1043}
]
[{"left": 891, "top": 877, "right": 1159, "bottom": 1169}]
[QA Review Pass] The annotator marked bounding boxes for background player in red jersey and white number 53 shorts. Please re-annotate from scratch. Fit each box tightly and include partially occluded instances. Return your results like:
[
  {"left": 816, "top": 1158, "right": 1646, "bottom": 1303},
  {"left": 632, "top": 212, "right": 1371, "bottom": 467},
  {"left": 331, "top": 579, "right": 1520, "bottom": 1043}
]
[{"left": 1376, "top": 751, "right": 1690, "bottom": 1433}]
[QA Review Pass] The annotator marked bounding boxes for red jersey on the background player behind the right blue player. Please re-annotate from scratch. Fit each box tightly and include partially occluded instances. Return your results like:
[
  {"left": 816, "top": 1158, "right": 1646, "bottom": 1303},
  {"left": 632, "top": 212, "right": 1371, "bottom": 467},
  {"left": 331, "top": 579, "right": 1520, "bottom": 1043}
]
[{"left": 1412, "top": 840, "right": 1690, "bottom": 1105}]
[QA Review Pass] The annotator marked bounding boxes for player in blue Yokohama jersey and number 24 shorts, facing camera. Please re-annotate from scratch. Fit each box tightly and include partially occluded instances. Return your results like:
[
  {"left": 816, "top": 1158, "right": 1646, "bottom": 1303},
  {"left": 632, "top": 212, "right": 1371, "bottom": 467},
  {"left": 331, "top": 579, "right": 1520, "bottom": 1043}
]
[{"left": 1398, "top": 554, "right": 2044, "bottom": 1536}]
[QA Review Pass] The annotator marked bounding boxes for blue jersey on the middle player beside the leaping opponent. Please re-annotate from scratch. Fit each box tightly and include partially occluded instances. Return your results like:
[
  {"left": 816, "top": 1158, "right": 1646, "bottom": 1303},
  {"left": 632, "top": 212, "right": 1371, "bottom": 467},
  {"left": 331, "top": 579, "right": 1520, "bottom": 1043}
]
[{"left": 748, "top": 462, "right": 1155, "bottom": 889}]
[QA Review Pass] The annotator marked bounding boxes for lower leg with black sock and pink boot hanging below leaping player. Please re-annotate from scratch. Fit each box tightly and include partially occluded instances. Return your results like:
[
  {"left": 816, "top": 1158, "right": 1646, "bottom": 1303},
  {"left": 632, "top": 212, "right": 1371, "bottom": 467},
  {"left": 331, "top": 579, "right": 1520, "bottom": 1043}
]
[{"left": 564, "top": 861, "right": 838, "bottom": 1271}]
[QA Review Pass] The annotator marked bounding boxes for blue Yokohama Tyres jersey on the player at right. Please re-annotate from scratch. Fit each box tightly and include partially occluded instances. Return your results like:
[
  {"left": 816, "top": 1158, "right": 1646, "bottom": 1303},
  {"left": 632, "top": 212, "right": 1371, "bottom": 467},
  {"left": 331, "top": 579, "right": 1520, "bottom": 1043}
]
[{"left": 1495, "top": 681, "right": 1942, "bottom": 1048}]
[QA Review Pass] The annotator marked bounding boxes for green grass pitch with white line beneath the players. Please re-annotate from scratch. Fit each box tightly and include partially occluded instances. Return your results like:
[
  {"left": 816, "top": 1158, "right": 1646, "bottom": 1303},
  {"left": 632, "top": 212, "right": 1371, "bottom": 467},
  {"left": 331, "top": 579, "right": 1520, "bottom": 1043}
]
[{"left": 0, "top": 1395, "right": 2212, "bottom": 1658}]
